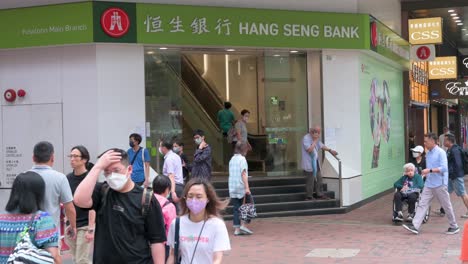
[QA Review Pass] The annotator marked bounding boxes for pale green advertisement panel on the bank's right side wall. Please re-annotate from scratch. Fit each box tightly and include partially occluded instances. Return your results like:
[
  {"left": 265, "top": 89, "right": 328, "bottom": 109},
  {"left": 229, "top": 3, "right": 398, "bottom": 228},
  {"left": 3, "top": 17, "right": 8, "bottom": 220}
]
[{"left": 359, "top": 56, "right": 405, "bottom": 199}]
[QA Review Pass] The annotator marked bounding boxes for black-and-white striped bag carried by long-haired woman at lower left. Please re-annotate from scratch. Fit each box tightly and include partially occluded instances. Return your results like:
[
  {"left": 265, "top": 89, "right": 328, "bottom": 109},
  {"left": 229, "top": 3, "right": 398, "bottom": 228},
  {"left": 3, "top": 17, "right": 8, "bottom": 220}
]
[{"left": 7, "top": 213, "right": 54, "bottom": 264}]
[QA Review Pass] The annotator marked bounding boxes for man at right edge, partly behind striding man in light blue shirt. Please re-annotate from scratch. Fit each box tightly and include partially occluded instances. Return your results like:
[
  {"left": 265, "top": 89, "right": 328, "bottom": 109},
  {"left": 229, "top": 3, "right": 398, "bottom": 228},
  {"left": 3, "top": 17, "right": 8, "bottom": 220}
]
[{"left": 439, "top": 133, "right": 468, "bottom": 218}]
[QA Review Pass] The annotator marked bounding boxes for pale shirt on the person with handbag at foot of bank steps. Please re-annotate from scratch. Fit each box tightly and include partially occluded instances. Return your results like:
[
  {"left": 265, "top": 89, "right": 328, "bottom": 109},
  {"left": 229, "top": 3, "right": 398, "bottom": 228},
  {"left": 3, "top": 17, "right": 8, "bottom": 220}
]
[{"left": 229, "top": 154, "right": 248, "bottom": 199}]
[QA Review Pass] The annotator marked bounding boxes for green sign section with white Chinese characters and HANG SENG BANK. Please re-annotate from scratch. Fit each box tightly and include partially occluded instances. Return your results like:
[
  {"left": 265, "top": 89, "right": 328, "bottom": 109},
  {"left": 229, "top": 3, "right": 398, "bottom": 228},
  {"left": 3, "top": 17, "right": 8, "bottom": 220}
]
[{"left": 136, "top": 4, "right": 370, "bottom": 49}]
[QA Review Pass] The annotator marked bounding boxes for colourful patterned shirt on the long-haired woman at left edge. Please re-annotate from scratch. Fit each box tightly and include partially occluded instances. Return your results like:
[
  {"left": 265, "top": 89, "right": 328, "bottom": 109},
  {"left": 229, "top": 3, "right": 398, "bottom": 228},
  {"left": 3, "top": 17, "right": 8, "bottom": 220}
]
[{"left": 0, "top": 211, "right": 58, "bottom": 263}]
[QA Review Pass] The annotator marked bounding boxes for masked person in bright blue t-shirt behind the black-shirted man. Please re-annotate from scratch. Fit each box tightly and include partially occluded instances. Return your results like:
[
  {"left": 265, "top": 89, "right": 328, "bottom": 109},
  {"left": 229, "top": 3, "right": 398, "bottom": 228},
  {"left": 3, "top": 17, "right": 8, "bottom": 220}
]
[{"left": 127, "top": 133, "right": 151, "bottom": 187}]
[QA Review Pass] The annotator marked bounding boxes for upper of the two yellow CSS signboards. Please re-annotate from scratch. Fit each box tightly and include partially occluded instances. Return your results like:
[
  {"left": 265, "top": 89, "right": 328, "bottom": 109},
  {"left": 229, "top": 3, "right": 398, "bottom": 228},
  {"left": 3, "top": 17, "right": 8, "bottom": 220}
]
[{"left": 408, "top": 17, "right": 442, "bottom": 45}]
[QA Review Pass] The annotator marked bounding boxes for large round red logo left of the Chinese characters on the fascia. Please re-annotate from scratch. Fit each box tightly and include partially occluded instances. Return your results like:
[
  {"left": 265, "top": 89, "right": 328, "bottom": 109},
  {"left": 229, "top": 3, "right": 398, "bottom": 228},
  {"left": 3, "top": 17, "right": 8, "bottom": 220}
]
[{"left": 101, "top": 7, "right": 130, "bottom": 38}]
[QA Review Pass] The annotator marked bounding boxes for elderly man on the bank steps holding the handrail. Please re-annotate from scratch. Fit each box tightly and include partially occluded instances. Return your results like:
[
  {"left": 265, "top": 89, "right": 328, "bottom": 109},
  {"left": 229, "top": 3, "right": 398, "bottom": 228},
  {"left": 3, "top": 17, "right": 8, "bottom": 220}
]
[{"left": 302, "top": 126, "right": 338, "bottom": 200}]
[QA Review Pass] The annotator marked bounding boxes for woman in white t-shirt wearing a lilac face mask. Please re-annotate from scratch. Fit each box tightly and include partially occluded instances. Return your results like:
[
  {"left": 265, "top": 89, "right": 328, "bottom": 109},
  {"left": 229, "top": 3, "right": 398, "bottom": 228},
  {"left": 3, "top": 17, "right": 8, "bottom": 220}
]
[{"left": 167, "top": 178, "right": 231, "bottom": 264}]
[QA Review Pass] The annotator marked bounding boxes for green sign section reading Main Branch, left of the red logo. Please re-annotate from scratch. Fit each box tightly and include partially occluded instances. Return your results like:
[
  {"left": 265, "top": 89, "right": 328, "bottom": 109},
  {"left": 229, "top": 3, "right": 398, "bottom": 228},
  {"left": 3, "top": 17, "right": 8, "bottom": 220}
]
[{"left": 0, "top": 2, "right": 93, "bottom": 48}]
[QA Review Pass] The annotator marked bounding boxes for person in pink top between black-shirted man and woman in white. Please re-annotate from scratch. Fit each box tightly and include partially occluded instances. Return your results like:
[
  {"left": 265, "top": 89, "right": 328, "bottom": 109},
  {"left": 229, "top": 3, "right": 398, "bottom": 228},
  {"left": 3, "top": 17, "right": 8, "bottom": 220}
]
[{"left": 153, "top": 175, "right": 177, "bottom": 261}]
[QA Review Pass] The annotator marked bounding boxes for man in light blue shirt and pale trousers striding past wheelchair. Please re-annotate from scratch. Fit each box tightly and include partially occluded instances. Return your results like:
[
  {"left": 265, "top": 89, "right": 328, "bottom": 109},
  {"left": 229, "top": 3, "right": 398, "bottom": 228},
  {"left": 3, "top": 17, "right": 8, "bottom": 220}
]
[{"left": 403, "top": 133, "right": 460, "bottom": 235}]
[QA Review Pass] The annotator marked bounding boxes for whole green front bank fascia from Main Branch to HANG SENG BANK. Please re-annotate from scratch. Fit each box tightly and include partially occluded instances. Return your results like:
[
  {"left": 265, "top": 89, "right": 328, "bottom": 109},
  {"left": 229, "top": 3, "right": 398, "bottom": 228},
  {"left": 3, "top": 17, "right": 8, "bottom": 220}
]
[{"left": 0, "top": 2, "right": 406, "bottom": 55}]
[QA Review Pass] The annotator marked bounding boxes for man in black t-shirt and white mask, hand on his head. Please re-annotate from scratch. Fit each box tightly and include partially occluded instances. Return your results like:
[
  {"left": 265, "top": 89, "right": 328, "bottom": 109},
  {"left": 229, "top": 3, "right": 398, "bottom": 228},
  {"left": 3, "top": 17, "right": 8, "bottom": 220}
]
[{"left": 74, "top": 149, "right": 166, "bottom": 264}]
